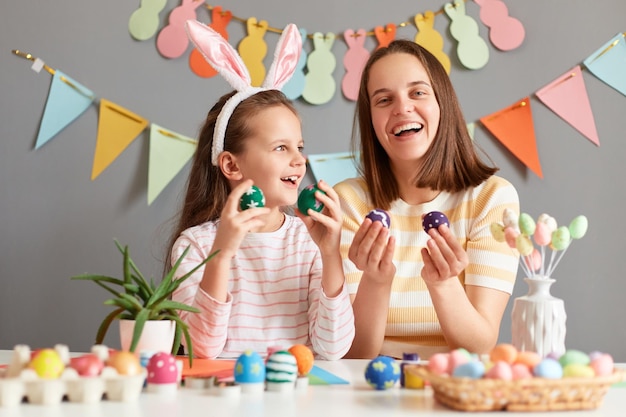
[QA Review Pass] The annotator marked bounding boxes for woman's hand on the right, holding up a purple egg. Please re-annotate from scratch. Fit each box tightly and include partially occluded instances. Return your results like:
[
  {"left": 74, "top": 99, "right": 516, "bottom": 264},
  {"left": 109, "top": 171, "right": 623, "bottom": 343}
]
[{"left": 422, "top": 224, "right": 469, "bottom": 284}]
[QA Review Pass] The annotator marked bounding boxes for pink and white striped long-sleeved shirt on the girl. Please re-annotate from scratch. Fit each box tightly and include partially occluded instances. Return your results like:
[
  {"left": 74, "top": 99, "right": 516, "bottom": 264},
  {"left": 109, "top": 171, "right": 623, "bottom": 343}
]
[{"left": 172, "top": 216, "right": 354, "bottom": 360}]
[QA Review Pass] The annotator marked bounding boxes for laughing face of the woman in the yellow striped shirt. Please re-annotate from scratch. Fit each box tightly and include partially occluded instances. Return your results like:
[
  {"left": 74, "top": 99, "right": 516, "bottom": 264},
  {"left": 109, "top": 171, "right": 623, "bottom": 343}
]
[{"left": 367, "top": 53, "right": 440, "bottom": 167}]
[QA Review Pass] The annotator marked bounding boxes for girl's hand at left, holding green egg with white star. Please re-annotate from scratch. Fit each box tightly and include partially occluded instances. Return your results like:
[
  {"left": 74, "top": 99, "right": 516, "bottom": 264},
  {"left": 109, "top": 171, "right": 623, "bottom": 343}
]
[{"left": 213, "top": 180, "right": 270, "bottom": 258}]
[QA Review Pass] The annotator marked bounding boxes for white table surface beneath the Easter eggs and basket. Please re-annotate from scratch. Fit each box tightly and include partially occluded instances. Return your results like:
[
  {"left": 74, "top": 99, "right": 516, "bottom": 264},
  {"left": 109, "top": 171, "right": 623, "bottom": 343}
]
[{"left": 0, "top": 351, "right": 626, "bottom": 417}]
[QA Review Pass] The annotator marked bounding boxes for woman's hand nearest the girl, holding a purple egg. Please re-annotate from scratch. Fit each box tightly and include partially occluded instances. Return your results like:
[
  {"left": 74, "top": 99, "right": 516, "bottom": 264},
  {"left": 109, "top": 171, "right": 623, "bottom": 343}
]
[{"left": 348, "top": 218, "right": 396, "bottom": 284}]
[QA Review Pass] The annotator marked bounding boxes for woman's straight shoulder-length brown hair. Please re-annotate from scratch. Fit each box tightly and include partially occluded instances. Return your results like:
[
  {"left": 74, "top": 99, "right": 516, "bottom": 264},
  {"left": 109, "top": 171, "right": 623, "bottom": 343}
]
[{"left": 352, "top": 40, "right": 498, "bottom": 209}]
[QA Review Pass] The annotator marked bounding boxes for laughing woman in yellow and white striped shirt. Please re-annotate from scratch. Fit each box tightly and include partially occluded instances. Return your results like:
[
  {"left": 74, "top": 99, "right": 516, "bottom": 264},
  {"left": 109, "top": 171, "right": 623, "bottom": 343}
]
[{"left": 335, "top": 40, "right": 519, "bottom": 358}]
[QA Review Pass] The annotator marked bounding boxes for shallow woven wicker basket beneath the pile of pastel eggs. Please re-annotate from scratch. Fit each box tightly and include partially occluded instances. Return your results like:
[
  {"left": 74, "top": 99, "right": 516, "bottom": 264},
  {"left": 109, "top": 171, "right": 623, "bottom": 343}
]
[{"left": 404, "top": 365, "right": 626, "bottom": 411}]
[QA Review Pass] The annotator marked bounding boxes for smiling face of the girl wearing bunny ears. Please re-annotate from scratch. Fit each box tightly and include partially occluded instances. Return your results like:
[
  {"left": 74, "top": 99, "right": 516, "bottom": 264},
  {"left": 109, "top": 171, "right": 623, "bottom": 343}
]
[{"left": 237, "top": 106, "right": 306, "bottom": 207}]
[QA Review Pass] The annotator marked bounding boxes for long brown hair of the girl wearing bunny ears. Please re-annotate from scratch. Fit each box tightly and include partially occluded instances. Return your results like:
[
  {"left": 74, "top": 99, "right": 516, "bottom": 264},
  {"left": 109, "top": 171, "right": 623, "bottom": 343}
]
[{"left": 166, "top": 90, "right": 298, "bottom": 269}]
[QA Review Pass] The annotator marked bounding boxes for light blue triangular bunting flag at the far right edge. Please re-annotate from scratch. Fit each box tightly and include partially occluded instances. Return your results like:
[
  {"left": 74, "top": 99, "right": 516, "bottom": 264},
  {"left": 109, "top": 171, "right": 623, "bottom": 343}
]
[{"left": 584, "top": 32, "right": 626, "bottom": 95}]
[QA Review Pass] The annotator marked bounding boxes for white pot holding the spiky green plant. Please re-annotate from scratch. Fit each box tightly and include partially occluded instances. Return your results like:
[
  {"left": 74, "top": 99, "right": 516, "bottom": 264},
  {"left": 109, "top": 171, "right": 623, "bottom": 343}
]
[{"left": 119, "top": 320, "right": 176, "bottom": 354}]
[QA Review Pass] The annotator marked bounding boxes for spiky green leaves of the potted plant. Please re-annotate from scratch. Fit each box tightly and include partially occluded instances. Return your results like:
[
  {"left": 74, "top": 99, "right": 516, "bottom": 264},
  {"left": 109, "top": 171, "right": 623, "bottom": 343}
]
[{"left": 71, "top": 240, "right": 217, "bottom": 365}]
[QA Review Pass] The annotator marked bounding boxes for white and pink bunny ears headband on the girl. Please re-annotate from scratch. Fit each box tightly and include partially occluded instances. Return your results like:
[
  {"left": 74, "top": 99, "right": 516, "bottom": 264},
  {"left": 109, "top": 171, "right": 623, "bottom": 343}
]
[{"left": 185, "top": 20, "right": 302, "bottom": 166}]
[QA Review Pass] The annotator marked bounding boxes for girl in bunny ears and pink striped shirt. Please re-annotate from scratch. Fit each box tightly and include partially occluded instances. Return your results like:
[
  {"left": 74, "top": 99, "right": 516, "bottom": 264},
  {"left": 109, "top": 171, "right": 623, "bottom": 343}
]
[{"left": 165, "top": 22, "right": 354, "bottom": 360}]
